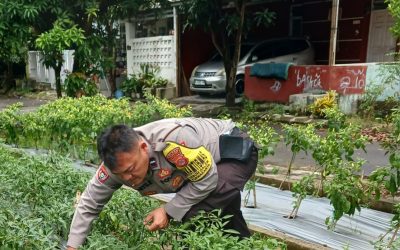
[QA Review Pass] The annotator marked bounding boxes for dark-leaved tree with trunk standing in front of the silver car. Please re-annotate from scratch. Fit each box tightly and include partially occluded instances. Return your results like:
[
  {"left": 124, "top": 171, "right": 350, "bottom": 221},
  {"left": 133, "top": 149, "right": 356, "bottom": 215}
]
[{"left": 181, "top": 0, "right": 275, "bottom": 106}]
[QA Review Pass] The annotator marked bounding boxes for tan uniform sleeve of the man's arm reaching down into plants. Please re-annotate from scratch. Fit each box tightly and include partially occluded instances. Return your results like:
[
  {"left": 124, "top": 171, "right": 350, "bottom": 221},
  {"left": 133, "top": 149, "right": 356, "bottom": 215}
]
[{"left": 67, "top": 166, "right": 122, "bottom": 248}]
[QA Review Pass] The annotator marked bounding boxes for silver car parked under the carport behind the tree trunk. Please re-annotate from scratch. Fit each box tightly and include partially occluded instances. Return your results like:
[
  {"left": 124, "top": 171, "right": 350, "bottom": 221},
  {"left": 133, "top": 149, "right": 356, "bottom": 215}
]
[{"left": 190, "top": 38, "right": 314, "bottom": 95}]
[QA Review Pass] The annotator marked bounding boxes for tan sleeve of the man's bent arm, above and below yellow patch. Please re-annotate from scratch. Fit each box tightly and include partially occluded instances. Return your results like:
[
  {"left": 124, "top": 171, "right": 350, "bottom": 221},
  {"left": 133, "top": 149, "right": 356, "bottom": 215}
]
[{"left": 164, "top": 127, "right": 218, "bottom": 221}]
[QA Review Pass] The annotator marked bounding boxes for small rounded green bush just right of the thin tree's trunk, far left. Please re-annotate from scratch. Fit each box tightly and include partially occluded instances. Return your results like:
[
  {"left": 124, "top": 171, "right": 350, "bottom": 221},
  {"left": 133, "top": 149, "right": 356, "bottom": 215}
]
[{"left": 64, "top": 72, "right": 98, "bottom": 98}]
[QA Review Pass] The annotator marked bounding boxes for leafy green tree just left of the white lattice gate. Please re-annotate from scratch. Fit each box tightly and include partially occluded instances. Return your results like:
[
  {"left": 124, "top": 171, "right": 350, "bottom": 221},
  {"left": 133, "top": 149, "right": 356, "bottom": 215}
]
[{"left": 66, "top": 0, "right": 169, "bottom": 95}]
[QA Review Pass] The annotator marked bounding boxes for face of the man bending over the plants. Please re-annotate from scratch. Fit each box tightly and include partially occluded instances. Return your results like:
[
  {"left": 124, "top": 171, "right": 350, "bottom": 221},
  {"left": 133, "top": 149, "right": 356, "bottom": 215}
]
[{"left": 113, "top": 141, "right": 149, "bottom": 187}]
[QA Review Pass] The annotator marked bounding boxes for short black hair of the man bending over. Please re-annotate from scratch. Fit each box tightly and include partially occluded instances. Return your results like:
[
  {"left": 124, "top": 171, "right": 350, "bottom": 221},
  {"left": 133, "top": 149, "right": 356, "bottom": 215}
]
[{"left": 97, "top": 125, "right": 140, "bottom": 170}]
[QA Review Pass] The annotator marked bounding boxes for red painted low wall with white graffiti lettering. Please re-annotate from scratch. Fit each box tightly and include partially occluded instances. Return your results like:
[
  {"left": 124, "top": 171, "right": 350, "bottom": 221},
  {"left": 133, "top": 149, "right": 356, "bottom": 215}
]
[{"left": 245, "top": 65, "right": 367, "bottom": 103}]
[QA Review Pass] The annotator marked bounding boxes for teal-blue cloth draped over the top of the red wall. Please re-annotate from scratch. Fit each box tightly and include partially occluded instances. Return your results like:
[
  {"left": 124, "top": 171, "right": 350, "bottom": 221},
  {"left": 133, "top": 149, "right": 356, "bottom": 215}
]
[{"left": 250, "top": 63, "right": 293, "bottom": 80}]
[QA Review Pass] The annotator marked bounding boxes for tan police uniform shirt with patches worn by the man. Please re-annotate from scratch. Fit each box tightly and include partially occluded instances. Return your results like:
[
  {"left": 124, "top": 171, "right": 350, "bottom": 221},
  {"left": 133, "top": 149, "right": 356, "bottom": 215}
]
[{"left": 68, "top": 118, "right": 235, "bottom": 247}]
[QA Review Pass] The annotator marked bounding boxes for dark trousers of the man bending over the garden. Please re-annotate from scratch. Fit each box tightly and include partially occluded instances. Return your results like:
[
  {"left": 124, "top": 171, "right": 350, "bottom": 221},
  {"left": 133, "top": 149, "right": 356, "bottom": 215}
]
[{"left": 183, "top": 148, "right": 258, "bottom": 238}]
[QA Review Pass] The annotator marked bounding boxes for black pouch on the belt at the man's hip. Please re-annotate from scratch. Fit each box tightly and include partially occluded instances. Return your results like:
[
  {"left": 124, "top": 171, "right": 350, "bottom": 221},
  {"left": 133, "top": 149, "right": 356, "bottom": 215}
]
[{"left": 219, "top": 127, "right": 254, "bottom": 162}]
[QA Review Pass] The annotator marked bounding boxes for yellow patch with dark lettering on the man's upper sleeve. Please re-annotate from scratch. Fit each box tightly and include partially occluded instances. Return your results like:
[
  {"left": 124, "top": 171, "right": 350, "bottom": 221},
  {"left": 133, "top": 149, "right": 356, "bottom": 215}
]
[{"left": 163, "top": 142, "right": 212, "bottom": 181}]
